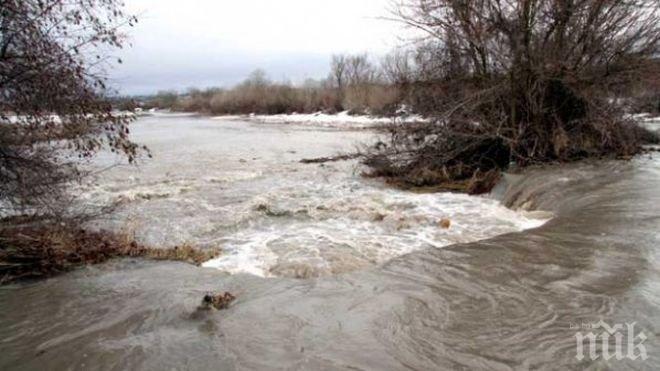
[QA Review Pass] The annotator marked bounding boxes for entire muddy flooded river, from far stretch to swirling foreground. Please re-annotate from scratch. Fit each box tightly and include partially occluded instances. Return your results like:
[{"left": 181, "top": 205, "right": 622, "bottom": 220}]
[{"left": 0, "top": 116, "right": 660, "bottom": 370}]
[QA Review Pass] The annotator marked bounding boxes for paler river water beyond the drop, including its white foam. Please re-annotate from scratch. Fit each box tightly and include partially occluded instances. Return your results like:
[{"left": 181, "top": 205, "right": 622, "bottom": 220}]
[{"left": 82, "top": 115, "right": 548, "bottom": 278}]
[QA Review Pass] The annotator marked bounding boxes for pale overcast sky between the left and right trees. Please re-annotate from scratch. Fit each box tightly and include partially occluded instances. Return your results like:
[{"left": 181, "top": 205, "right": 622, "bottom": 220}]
[{"left": 111, "top": 0, "right": 403, "bottom": 94}]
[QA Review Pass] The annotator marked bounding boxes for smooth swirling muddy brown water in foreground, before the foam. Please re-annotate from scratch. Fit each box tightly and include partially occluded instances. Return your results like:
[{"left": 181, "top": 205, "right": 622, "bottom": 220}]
[{"left": 0, "top": 115, "right": 660, "bottom": 370}]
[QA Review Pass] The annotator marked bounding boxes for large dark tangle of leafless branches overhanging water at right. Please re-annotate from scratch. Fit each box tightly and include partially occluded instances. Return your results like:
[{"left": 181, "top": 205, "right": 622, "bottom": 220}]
[{"left": 367, "top": 0, "right": 660, "bottom": 192}]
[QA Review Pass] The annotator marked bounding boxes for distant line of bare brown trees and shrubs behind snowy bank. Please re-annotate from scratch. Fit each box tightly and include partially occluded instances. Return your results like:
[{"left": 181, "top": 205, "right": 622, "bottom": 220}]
[{"left": 143, "top": 43, "right": 660, "bottom": 122}]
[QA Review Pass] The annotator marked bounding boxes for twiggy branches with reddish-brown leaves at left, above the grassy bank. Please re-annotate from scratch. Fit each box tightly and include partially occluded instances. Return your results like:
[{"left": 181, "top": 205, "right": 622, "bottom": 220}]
[{"left": 0, "top": 0, "right": 138, "bottom": 214}]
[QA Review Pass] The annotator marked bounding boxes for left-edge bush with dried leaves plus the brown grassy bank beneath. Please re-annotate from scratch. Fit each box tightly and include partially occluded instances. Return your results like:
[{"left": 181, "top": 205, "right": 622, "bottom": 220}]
[{"left": 0, "top": 0, "right": 164, "bottom": 283}]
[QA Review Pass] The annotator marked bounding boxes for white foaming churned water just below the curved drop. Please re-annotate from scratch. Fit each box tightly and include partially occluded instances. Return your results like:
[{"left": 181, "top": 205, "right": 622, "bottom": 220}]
[{"left": 203, "top": 184, "right": 549, "bottom": 277}]
